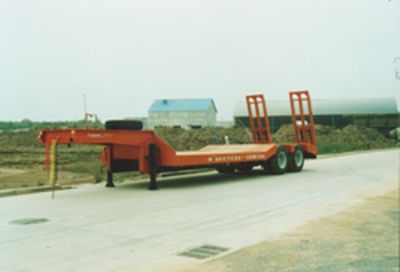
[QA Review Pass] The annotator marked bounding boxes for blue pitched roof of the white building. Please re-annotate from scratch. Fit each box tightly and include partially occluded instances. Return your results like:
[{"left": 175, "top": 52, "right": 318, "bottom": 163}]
[{"left": 149, "top": 98, "right": 217, "bottom": 112}]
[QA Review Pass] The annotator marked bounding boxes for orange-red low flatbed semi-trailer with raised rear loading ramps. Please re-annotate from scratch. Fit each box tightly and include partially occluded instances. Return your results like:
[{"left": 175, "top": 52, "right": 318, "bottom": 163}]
[{"left": 39, "top": 91, "right": 317, "bottom": 190}]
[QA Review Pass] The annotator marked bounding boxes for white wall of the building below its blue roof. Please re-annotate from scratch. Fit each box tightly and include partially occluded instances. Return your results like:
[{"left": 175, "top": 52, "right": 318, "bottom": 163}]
[{"left": 149, "top": 109, "right": 216, "bottom": 128}]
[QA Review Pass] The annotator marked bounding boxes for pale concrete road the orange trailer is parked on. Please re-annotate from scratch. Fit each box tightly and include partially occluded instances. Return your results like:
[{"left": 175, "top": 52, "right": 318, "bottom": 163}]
[{"left": 0, "top": 149, "right": 399, "bottom": 272}]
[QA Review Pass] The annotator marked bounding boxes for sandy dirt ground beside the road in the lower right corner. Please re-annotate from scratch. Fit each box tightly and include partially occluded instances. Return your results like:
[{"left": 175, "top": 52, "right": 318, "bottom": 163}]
[{"left": 181, "top": 190, "right": 400, "bottom": 272}]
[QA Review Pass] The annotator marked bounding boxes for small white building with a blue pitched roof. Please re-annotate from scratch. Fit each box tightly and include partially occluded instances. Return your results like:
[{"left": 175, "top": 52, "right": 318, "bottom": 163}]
[{"left": 149, "top": 98, "right": 218, "bottom": 129}]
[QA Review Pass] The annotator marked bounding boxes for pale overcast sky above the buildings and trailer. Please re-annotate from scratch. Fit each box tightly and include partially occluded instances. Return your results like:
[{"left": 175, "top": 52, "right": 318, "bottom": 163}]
[{"left": 0, "top": 0, "right": 400, "bottom": 121}]
